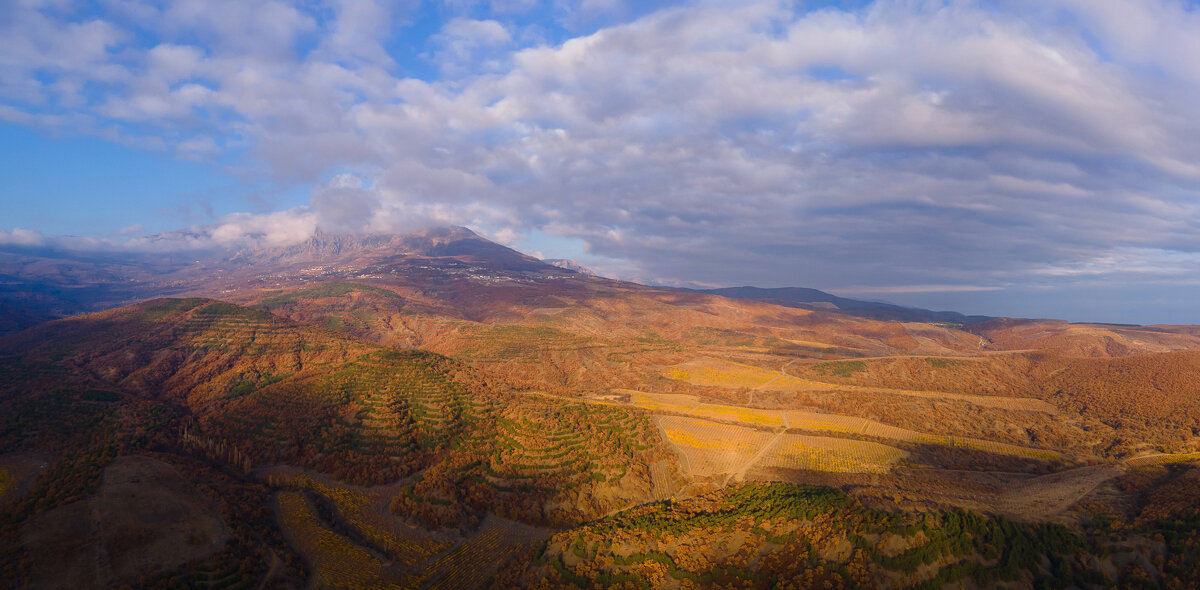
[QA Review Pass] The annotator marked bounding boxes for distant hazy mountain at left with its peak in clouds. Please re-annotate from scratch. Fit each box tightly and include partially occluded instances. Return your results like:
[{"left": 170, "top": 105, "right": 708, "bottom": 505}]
[{"left": 0, "top": 228, "right": 568, "bottom": 335}]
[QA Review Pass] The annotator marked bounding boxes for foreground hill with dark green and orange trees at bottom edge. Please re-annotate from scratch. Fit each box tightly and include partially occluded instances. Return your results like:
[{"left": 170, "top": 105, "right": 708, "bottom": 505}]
[{"left": 521, "top": 483, "right": 1089, "bottom": 589}]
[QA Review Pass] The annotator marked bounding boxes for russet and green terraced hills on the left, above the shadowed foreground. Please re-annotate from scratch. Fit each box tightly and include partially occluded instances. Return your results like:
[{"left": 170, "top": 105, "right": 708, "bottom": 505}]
[{"left": 0, "top": 299, "right": 676, "bottom": 524}]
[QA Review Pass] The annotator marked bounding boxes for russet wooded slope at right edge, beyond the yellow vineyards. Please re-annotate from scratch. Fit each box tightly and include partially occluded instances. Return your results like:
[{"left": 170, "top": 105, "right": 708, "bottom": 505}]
[{"left": 787, "top": 350, "right": 1200, "bottom": 456}]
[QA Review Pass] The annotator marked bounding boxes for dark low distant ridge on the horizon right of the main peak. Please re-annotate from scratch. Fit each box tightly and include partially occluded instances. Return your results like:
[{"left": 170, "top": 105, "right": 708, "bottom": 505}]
[{"left": 697, "top": 287, "right": 992, "bottom": 325}]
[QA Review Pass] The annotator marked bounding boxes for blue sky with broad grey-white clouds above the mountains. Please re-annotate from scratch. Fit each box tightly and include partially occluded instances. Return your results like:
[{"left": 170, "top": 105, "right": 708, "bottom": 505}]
[{"left": 0, "top": 0, "right": 1200, "bottom": 324}]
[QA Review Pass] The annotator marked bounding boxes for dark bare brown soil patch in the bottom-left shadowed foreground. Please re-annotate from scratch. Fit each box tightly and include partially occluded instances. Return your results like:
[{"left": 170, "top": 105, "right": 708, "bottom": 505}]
[{"left": 22, "top": 456, "right": 229, "bottom": 589}]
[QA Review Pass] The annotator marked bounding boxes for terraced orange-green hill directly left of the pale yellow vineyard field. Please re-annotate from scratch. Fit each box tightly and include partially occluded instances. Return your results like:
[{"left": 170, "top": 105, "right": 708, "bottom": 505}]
[{"left": 391, "top": 398, "right": 665, "bottom": 526}]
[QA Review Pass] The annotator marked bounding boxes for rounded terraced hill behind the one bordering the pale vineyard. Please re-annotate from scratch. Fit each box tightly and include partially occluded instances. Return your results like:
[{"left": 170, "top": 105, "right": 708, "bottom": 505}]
[{"left": 196, "top": 350, "right": 492, "bottom": 483}]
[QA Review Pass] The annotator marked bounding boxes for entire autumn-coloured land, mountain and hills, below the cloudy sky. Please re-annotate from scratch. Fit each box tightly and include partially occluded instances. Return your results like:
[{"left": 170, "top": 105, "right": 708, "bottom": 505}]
[{"left": 7, "top": 228, "right": 1200, "bottom": 589}]
